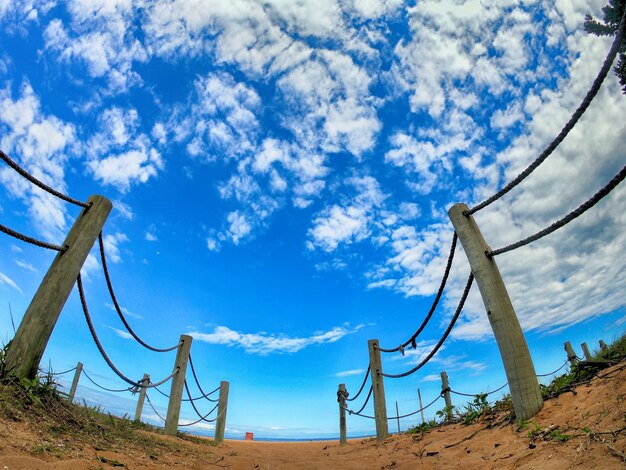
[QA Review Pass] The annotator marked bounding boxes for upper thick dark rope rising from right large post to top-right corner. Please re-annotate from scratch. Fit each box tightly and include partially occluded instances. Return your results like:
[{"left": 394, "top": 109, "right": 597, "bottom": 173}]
[{"left": 465, "top": 9, "right": 626, "bottom": 215}]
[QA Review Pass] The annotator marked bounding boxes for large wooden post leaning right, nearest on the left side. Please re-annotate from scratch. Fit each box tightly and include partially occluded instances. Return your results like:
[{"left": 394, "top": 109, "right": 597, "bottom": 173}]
[{"left": 5, "top": 196, "right": 113, "bottom": 378}]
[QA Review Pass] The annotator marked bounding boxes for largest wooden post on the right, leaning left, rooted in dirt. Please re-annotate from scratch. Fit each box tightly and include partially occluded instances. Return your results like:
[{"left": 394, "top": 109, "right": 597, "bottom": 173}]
[{"left": 448, "top": 204, "right": 543, "bottom": 419}]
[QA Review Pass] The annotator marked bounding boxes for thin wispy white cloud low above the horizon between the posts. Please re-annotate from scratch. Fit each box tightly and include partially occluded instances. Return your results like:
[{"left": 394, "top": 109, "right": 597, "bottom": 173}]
[{"left": 187, "top": 325, "right": 363, "bottom": 356}]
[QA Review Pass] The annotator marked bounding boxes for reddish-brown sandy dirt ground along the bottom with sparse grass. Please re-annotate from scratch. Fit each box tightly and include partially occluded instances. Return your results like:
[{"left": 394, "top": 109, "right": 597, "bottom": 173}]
[{"left": 0, "top": 363, "right": 626, "bottom": 470}]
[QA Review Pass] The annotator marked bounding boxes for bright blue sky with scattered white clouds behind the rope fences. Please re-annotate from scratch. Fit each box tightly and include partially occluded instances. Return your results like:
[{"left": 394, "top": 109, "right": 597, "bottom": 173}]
[{"left": 0, "top": 0, "right": 626, "bottom": 438}]
